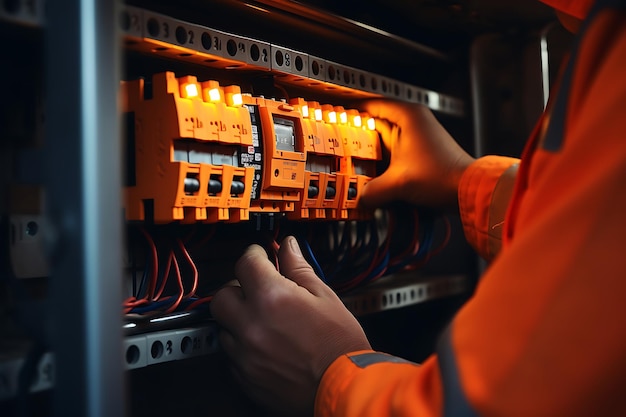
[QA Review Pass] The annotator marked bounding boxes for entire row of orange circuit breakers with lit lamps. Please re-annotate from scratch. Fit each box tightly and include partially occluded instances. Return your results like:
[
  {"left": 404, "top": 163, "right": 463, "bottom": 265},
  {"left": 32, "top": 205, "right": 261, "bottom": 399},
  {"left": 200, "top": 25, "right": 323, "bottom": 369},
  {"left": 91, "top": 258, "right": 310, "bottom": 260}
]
[{"left": 117, "top": 72, "right": 381, "bottom": 224}]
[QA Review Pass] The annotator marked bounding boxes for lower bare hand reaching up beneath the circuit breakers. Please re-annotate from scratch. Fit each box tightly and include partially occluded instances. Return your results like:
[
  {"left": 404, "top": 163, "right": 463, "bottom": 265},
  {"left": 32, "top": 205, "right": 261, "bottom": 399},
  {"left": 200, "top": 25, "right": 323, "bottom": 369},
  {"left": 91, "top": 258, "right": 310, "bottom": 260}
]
[{"left": 211, "top": 237, "right": 370, "bottom": 416}]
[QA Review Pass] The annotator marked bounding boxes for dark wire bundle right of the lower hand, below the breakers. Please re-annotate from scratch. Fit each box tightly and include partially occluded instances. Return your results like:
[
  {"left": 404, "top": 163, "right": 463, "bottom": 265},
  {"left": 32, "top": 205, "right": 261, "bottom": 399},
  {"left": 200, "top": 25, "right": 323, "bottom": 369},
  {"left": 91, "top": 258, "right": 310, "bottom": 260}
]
[{"left": 290, "top": 209, "right": 450, "bottom": 293}]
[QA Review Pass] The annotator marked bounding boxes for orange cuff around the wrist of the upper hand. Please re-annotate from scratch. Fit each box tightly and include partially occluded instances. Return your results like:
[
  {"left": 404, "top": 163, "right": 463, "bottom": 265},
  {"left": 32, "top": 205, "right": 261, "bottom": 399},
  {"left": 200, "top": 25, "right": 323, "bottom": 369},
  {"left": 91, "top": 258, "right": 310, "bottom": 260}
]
[{"left": 459, "top": 156, "right": 519, "bottom": 260}]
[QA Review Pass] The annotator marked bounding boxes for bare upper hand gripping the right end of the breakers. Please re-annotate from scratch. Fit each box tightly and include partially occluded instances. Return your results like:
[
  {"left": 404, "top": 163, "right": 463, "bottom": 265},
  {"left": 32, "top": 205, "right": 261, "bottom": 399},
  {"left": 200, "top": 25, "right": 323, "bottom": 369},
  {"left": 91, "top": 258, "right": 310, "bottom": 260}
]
[{"left": 359, "top": 100, "right": 474, "bottom": 208}]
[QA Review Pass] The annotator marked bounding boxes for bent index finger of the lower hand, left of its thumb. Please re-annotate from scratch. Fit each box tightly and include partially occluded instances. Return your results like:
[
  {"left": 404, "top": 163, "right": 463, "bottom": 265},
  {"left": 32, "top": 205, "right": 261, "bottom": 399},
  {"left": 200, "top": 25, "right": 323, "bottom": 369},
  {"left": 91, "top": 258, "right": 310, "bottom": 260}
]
[{"left": 235, "top": 245, "right": 284, "bottom": 298}]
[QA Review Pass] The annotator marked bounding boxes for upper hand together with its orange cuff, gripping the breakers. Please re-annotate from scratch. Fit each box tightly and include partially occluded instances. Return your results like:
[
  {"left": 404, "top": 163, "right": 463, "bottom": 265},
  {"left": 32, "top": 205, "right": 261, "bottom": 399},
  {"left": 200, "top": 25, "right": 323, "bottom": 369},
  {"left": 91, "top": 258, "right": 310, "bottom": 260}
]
[{"left": 359, "top": 100, "right": 519, "bottom": 260}]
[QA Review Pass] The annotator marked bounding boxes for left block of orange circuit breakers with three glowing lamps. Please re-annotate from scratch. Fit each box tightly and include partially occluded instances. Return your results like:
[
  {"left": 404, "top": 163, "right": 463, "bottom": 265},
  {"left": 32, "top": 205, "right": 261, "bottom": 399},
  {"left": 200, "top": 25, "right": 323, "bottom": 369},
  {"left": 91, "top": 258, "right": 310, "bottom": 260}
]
[{"left": 122, "top": 72, "right": 254, "bottom": 223}]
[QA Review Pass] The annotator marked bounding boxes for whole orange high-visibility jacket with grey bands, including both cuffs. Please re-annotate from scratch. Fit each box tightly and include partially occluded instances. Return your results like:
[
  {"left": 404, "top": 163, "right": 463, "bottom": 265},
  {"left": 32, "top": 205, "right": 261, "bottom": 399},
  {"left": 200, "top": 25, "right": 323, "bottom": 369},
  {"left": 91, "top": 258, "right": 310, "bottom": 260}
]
[{"left": 315, "top": 0, "right": 626, "bottom": 417}]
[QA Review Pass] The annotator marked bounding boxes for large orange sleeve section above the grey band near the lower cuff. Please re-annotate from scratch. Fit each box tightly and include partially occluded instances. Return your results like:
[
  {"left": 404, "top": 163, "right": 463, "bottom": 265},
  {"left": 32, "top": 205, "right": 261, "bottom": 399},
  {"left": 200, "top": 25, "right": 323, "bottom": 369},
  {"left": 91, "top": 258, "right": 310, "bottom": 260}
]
[{"left": 451, "top": 8, "right": 626, "bottom": 416}]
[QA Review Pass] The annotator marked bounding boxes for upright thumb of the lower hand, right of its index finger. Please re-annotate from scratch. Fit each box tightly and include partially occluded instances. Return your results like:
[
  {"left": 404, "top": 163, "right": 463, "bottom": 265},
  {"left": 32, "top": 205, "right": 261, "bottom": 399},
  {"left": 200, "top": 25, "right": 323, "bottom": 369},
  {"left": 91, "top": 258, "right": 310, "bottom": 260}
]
[{"left": 278, "top": 236, "right": 328, "bottom": 296}]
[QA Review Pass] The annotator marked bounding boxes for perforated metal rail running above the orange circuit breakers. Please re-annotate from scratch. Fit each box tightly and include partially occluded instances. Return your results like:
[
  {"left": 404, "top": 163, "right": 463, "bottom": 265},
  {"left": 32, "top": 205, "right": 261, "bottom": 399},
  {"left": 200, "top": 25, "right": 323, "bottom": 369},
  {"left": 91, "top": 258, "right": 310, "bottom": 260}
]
[{"left": 120, "top": 6, "right": 465, "bottom": 117}]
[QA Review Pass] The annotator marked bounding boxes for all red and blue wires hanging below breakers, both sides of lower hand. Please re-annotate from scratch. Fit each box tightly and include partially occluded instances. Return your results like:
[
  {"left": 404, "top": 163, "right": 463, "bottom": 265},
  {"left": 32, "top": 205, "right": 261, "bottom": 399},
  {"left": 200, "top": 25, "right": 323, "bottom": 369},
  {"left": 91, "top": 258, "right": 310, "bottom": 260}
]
[{"left": 123, "top": 207, "right": 450, "bottom": 317}]
